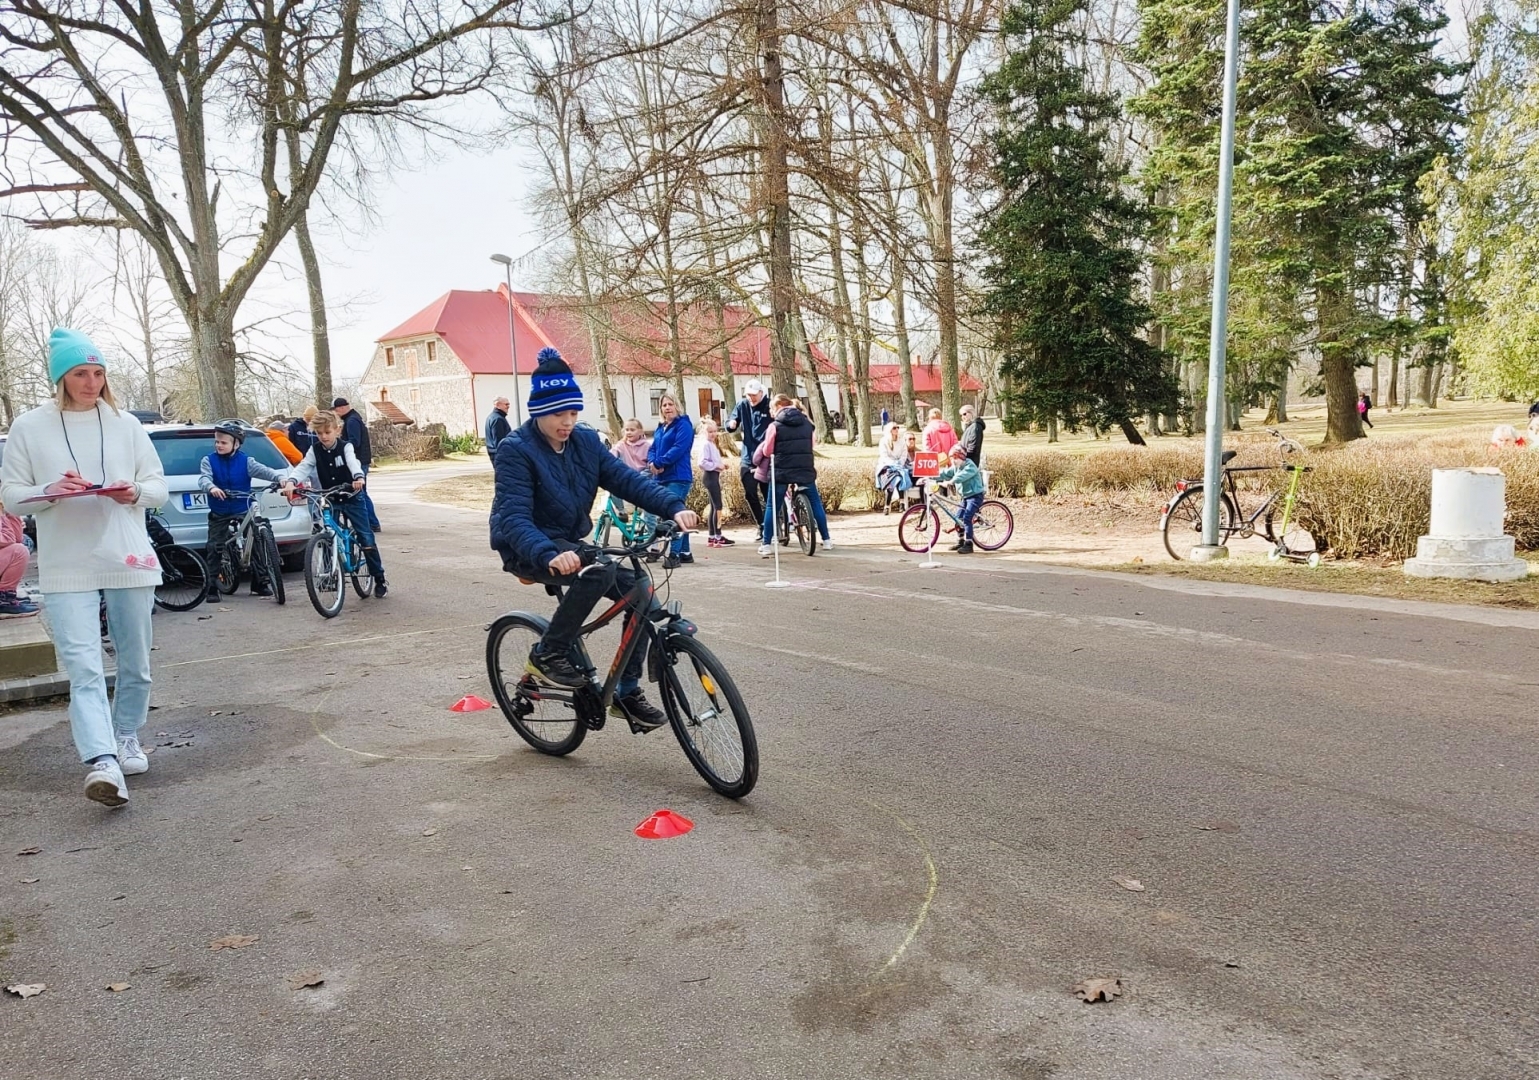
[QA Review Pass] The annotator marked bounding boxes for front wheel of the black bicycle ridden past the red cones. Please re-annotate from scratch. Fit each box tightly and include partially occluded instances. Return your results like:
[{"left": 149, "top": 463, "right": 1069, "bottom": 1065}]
[{"left": 657, "top": 634, "right": 759, "bottom": 798}]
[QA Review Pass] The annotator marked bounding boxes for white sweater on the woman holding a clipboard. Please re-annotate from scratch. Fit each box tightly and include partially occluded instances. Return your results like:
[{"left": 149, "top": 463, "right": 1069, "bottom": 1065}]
[{"left": 0, "top": 402, "right": 166, "bottom": 594}]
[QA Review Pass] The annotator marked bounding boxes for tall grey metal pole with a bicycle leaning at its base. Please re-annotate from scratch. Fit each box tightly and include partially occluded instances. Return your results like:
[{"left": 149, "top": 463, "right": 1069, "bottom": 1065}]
[{"left": 1191, "top": 0, "right": 1240, "bottom": 558}]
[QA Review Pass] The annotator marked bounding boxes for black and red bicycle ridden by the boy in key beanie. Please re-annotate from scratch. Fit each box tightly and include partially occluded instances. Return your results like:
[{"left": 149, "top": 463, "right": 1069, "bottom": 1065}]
[{"left": 486, "top": 522, "right": 759, "bottom": 798}]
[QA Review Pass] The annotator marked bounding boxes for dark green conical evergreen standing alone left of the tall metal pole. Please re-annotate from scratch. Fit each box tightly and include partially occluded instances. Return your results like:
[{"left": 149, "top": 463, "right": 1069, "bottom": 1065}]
[{"left": 979, "top": 0, "right": 1176, "bottom": 445}]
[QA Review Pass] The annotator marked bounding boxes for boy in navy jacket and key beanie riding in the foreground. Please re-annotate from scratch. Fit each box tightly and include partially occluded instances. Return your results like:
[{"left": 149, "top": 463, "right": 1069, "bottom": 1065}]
[{"left": 491, "top": 349, "right": 699, "bottom": 731}]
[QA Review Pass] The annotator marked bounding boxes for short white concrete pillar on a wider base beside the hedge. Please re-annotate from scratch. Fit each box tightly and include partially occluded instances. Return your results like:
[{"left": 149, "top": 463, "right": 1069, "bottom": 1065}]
[{"left": 1405, "top": 468, "right": 1528, "bottom": 582}]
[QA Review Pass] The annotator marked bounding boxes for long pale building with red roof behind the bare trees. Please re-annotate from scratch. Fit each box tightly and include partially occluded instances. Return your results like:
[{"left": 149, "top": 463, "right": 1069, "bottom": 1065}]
[{"left": 360, "top": 292, "right": 843, "bottom": 434}]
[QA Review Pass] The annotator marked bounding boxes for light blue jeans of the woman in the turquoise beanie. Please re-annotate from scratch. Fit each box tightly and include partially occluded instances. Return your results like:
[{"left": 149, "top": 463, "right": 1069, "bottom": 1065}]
[{"left": 45, "top": 586, "right": 155, "bottom": 762}]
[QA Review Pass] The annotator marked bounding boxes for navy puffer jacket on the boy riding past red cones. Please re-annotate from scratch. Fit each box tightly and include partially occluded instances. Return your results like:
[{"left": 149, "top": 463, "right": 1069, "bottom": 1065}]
[{"left": 491, "top": 420, "right": 683, "bottom": 568}]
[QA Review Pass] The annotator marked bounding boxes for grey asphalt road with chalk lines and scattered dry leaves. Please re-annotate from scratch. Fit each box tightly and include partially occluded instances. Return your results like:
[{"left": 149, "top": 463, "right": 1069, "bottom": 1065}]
[{"left": 0, "top": 474, "right": 1539, "bottom": 1080}]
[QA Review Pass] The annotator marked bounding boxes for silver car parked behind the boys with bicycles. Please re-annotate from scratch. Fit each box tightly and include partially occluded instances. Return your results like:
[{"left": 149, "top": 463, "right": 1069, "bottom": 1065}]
[{"left": 145, "top": 423, "right": 311, "bottom": 571}]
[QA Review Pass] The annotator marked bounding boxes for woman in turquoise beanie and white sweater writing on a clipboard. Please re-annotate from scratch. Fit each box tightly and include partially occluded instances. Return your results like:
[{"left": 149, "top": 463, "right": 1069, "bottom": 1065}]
[{"left": 0, "top": 329, "right": 166, "bottom": 806}]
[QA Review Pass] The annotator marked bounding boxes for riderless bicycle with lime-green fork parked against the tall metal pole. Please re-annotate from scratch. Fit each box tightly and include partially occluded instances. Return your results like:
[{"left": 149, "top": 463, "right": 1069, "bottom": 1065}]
[{"left": 1159, "top": 428, "right": 1320, "bottom": 566}]
